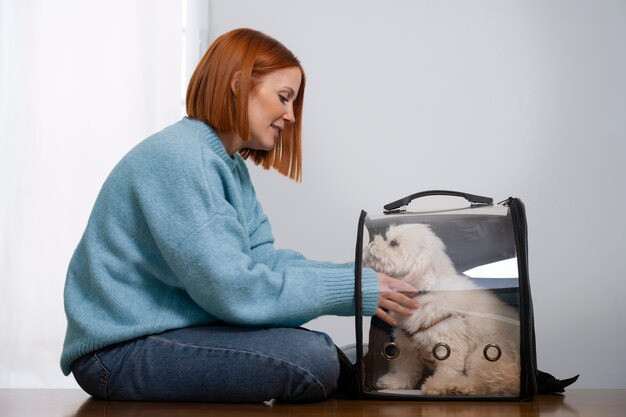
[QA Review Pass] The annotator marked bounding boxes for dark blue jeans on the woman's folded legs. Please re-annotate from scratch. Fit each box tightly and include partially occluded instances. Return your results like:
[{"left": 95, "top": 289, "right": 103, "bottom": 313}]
[{"left": 72, "top": 326, "right": 339, "bottom": 402}]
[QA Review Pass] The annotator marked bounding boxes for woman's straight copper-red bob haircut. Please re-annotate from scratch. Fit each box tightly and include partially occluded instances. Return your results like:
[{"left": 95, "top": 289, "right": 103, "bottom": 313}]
[{"left": 187, "top": 29, "right": 305, "bottom": 182}]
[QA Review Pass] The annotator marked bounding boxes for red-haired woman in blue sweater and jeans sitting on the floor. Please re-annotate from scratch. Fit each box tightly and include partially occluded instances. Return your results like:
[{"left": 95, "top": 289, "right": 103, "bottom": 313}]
[{"left": 61, "top": 29, "right": 417, "bottom": 402}]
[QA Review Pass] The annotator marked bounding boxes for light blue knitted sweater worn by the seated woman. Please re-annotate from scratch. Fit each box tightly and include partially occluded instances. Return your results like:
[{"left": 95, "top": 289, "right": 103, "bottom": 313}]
[{"left": 61, "top": 118, "right": 378, "bottom": 375}]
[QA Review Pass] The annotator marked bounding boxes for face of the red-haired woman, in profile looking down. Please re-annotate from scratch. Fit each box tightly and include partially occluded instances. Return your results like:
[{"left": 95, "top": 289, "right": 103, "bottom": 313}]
[{"left": 245, "top": 67, "right": 302, "bottom": 151}]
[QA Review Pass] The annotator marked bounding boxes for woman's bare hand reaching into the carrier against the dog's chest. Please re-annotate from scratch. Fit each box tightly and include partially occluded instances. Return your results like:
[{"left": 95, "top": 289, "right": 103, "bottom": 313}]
[{"left": 376, "top": 272, "right": 419, "bottom": 326}]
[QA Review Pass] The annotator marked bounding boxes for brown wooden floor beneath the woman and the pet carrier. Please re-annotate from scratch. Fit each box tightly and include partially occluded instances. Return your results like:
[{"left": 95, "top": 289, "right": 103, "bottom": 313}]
[{"left": 0, "top": 389, "right": 626, "bottom": 417}]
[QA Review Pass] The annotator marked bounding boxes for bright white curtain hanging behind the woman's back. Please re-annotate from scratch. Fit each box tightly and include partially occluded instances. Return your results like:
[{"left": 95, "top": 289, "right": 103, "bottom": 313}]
[{"left": 0, "top": 0, "right": 185, "bottom": 388}]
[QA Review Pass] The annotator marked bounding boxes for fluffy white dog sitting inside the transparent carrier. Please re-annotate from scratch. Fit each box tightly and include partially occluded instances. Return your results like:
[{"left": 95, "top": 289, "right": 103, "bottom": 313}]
[{"left": 363, "top": 224, "right": 520, "bottom": 395}]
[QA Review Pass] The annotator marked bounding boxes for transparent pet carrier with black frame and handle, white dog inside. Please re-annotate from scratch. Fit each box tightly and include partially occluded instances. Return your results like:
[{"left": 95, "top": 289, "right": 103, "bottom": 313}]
[{"left": 351, "top": 191, "right": 536, "bottom": 400}]
